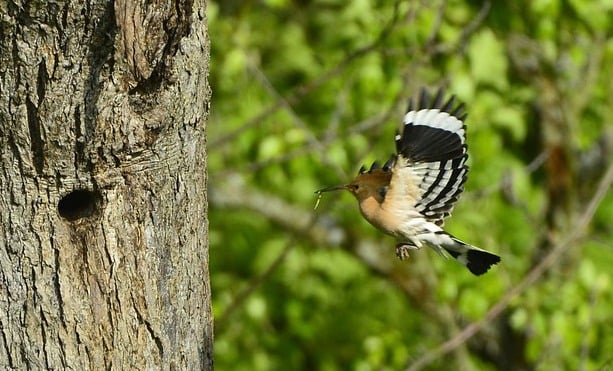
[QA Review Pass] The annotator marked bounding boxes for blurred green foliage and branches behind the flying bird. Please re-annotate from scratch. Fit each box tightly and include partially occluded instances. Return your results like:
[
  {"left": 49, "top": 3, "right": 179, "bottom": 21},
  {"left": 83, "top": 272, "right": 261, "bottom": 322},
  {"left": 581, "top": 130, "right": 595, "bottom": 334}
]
[{"left": 208, "top": 0, "right": 613, "bottom": 370}]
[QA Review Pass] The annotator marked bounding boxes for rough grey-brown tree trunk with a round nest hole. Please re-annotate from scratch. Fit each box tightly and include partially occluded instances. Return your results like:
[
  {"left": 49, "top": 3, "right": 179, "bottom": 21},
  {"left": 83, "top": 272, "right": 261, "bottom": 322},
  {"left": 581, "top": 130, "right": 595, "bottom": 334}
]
[{"left": 0, "top": 0, "right": 213, "bottom": 370}]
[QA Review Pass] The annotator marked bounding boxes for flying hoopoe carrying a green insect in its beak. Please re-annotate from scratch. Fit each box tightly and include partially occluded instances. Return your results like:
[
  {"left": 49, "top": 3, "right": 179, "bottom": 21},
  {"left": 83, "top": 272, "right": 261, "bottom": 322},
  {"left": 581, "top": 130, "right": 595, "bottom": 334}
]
[{"left": 315, "top": 89, "right": 500, "bottom": 275}]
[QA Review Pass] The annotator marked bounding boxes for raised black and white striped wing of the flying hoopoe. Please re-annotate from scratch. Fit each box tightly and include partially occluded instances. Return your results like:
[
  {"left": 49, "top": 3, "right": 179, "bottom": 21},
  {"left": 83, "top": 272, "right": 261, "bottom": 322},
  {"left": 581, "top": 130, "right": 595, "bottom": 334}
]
[{"left": 391, "top": 89, "right": 468, "bottom": 226}]
